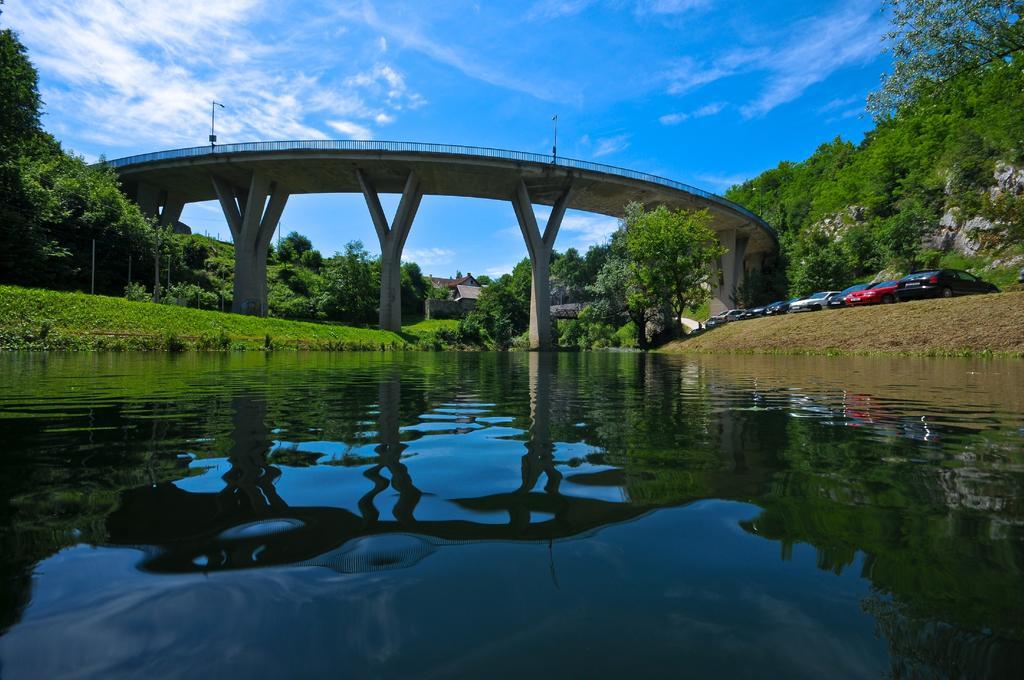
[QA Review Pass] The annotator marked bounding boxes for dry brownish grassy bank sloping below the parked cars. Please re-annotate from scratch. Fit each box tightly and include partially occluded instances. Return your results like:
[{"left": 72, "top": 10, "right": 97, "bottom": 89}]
[{"left": 663, "top": 292, "right": 1024, "bottom": 356}]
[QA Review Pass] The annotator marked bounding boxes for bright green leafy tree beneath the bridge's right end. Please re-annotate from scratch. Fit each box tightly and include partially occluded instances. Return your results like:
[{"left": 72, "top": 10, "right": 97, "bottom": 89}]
[{"left": 626, "top": 204, "right": 726, "bottom": 333}]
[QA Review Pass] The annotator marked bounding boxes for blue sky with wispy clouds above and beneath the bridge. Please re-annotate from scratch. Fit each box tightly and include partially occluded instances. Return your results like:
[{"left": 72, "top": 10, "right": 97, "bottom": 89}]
[{"left": 6, "top": 0, "right": 888, "bottom": 274}]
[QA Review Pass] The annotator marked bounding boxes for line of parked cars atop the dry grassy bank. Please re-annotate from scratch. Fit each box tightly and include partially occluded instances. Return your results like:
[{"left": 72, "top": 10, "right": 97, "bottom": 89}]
[{"left": 705, "top": 269, "right": 999, "bottom": 328}]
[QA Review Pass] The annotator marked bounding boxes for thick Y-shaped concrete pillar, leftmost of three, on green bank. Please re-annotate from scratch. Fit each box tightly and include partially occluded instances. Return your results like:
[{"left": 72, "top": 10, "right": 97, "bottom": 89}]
[{"left": 212, "top": 172, "right": 288, "bottom": 316}]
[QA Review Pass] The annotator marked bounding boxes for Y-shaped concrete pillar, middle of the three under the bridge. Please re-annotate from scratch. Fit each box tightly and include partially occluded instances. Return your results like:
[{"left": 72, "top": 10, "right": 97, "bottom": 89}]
[{"left": 355, "top": 169, "right": 423, "bottom": 332}]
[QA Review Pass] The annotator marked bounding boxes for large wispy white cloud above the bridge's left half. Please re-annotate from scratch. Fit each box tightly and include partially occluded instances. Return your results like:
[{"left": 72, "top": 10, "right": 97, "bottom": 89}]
[{"left": 4, "top": 0, "right": 422, "bottom": 146}]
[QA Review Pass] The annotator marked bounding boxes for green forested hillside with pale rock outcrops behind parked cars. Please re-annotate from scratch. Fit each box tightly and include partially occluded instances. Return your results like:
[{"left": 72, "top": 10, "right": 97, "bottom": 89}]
[{"left": 726, "top": 58, "right": 1024, "bottom": 301}]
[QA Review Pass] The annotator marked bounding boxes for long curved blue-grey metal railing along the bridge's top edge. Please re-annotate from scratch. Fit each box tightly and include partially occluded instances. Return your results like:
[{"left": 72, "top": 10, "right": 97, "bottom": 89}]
[{"left": 106, "top": 139, "right": 774, "bottom": 235}]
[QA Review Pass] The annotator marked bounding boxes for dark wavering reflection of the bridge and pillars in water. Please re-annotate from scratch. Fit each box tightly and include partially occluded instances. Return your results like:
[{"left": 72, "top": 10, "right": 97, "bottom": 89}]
[{"left": 108, "top": 353, "right": 651, "bottom": 571}]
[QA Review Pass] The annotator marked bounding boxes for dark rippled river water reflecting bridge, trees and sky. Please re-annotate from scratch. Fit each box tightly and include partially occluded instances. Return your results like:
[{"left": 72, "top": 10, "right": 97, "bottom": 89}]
[{"left": 0, "top": 353, "right": 1024, "bottom": 678}]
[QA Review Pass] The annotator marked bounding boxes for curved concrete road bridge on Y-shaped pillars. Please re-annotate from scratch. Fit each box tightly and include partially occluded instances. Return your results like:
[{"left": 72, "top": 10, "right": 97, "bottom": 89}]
[{"left": 110, "top": 140, "right": 777, "bottom": 348}]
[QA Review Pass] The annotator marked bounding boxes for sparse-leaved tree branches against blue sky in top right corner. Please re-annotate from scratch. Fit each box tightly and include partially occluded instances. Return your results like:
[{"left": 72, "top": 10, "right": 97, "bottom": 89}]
[{"left": 867, "top": 0, "right": 1024, "bottom": 117}]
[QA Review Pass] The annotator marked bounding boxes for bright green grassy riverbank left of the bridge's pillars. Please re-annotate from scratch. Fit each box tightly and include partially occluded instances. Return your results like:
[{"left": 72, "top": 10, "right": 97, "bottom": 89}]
[{"left": 0, "top": 286, "right": 454, "bottom": 351}]
